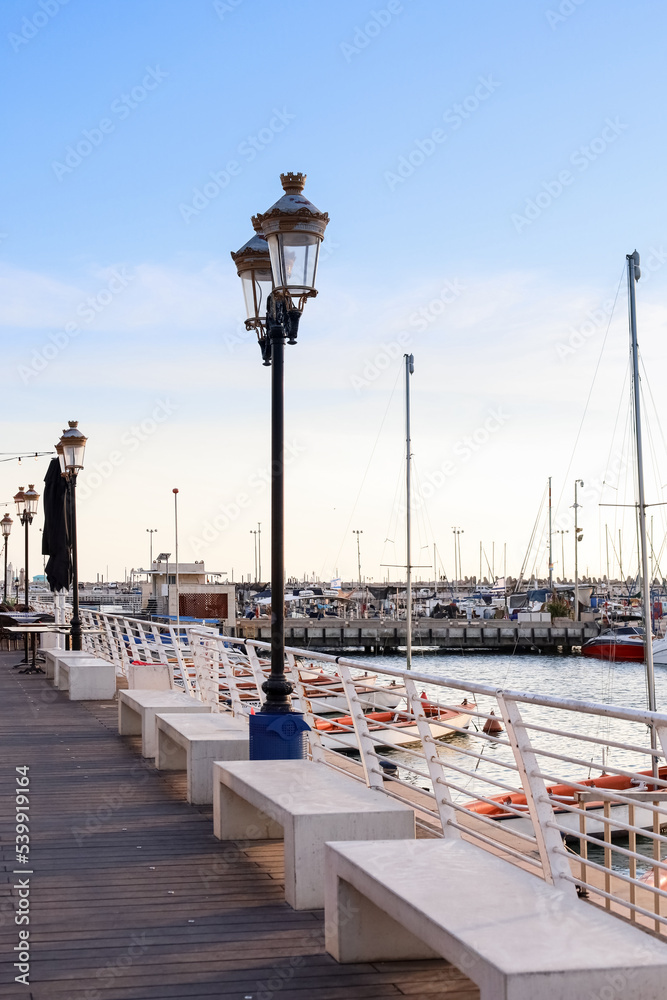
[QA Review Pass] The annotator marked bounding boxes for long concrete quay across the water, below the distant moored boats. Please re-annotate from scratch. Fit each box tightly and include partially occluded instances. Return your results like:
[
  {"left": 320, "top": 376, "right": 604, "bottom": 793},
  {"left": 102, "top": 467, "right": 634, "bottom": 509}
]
[{"left": 234, "top": 618, "right": 598, "bottom": 654}]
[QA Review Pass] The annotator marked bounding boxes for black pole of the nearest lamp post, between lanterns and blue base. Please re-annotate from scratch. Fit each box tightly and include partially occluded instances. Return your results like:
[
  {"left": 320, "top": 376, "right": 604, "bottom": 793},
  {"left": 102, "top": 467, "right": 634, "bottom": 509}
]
[{"left": 261, "top": 320, "right": 292, "bottom": 714}]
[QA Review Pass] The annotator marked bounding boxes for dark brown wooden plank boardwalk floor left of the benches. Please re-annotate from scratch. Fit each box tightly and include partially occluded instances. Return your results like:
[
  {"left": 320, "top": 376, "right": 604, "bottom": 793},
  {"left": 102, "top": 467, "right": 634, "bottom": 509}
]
[{"left": 0, "top": 653, "right": 479, "bottom": 1000}]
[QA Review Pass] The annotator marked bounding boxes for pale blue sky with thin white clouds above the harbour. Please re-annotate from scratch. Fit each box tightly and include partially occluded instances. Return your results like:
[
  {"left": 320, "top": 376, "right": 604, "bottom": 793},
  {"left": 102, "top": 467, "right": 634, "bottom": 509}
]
[{"left": 0, "top": 0, "right": 667, "bottom": 582}]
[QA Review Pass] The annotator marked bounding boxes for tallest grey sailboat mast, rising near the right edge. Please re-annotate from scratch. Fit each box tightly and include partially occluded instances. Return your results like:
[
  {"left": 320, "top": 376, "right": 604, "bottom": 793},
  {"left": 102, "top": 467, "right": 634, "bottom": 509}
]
[{"left": 627, "top": 250, "right": 656, "bottom": 720}]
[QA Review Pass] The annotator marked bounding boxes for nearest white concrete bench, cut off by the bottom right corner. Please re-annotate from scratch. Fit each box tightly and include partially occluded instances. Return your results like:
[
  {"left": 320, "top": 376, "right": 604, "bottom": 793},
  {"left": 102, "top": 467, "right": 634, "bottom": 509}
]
[{"left": 325, "top": 840, "right": 667, "bottom": 1000}]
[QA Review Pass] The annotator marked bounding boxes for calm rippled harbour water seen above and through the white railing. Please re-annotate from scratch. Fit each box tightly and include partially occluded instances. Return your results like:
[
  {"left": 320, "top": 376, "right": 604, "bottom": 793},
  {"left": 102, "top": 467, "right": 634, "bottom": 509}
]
[{"left": 349, "top": 652, "right": 667, "bottom": 870}]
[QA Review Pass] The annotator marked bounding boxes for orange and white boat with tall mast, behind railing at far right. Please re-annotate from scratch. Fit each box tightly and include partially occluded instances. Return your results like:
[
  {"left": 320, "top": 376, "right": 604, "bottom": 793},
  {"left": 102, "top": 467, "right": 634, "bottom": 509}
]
[{"left": 467, "top": 250, "right": 667, "bottom": 836}]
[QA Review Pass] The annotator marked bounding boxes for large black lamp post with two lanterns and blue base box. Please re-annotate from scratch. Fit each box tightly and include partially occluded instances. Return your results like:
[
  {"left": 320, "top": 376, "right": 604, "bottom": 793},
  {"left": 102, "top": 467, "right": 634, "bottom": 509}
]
[{"left": 232, "top": 173, "right": 329, "bottom": 759}]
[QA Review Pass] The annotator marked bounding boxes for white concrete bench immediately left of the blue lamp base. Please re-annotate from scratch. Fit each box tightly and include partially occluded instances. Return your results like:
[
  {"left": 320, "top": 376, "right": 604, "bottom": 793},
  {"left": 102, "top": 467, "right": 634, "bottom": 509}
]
[{"left": 155, "top": 712, "right": 248, "bottom": 805}]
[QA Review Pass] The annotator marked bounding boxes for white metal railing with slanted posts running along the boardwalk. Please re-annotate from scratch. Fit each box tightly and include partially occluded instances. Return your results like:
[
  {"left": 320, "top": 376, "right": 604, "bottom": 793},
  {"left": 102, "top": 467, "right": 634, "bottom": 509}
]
[{"left": 79, "top": 612, "right": 667, "bottom": 934}]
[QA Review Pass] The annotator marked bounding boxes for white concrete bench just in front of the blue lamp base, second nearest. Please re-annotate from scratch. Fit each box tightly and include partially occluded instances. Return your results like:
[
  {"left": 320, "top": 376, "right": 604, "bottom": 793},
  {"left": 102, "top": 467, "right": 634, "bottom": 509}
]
[{"left": 213, "top": 760, "right": 415, "bottom": 910}]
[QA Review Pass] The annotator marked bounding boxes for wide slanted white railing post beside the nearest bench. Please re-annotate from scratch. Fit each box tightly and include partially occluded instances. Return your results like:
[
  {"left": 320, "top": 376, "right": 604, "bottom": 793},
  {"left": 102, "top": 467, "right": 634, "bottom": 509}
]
[{"left": 496, "top": 691, "right": 576, "bottom": 896}]
